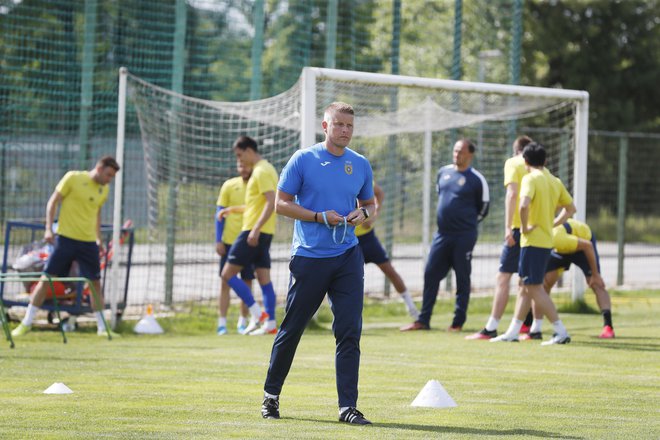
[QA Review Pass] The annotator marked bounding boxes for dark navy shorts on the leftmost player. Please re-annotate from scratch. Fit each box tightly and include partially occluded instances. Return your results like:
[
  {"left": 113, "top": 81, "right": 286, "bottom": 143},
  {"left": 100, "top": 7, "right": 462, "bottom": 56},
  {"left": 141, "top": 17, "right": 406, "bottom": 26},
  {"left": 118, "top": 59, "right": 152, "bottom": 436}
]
[{"left": 44, "top": 235, "right": 101, "bottom": 280}]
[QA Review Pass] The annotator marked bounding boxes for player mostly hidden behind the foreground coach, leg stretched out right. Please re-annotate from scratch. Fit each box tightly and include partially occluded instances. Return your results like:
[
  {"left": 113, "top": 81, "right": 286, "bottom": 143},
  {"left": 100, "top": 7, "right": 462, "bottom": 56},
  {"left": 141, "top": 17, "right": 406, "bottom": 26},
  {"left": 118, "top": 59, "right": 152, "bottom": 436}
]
[{"left": 355, "top": 182, "right": 419, "bottom": 319}]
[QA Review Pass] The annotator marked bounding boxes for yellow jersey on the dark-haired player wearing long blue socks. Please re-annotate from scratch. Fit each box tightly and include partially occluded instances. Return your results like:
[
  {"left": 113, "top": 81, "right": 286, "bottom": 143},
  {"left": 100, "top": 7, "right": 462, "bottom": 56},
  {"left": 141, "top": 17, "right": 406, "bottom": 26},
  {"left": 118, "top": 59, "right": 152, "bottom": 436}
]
[{"left": 242, "top": 159, "right": 278, "bottom": 234}]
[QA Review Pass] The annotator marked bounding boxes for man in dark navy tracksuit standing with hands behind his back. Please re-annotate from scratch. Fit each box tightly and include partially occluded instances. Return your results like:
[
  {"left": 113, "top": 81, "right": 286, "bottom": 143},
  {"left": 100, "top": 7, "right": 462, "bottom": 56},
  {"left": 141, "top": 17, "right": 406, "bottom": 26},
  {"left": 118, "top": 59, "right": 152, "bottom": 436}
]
[{"left": 401, "top": 139, "right": 490, "bottom": 331}]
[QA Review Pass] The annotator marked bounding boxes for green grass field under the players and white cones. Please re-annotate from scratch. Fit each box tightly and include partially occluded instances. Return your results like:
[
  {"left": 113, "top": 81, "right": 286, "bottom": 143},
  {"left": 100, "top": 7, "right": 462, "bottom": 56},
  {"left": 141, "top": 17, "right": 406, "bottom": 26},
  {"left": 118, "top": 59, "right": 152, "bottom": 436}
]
[{"left": 0, "top": 291, "right": 660, "bottom": 439}]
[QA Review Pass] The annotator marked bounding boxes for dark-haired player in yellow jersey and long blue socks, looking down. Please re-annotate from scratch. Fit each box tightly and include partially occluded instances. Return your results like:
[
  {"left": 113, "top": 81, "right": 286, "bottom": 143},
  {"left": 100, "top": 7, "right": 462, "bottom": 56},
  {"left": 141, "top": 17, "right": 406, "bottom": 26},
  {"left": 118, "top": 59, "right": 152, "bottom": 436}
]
[{"left": 222, "top": 136, "right": 278, "bottom": 335}]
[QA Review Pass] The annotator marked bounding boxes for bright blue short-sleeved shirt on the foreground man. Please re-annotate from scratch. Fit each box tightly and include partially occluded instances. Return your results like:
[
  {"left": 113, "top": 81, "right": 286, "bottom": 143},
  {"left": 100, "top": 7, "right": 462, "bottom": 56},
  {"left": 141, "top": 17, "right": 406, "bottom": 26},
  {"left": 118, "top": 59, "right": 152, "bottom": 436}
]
[{"left": 277, "top": 143, "right": 374, "bottom": 258}]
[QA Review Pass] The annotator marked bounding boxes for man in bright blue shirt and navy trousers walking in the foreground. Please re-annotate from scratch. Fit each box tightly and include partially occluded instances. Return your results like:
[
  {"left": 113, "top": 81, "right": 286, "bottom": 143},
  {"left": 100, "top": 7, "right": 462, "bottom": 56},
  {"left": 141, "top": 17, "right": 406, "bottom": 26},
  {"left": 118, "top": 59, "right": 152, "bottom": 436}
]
[{"left": 261, "top": 102, "right": 375, "bottom": 425}]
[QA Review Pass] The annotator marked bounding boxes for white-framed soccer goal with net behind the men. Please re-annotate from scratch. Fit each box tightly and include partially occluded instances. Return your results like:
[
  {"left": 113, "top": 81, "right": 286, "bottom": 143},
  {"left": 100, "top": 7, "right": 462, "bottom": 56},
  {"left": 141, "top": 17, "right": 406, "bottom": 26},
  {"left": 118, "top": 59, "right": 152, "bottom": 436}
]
[{"left": 114, "top": 68, "right": 589, "bottom": 312}]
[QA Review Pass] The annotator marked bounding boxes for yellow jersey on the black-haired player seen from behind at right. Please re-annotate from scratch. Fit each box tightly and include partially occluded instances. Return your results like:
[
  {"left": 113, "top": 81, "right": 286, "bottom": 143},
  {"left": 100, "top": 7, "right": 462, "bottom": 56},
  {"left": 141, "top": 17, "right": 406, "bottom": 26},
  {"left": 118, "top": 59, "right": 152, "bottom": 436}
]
[{"left": 520, "top": 168, "right": 573, "bottom": 249}]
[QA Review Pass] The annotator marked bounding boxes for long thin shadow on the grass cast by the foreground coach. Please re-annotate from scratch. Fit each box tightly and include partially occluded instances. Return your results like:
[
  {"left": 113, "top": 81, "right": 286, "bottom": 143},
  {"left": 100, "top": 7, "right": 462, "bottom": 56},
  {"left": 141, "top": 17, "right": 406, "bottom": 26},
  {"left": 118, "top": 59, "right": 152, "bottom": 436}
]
[{"left": 292, "top": 417, "right": 584, "bottom": 440}]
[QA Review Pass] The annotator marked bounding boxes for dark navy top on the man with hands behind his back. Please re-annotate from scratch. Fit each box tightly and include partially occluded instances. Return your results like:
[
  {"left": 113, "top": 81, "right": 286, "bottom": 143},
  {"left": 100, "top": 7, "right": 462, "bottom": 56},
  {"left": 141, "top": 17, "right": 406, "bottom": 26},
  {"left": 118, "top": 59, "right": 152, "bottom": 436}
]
[{"left": 436, "top": 165, "right": 490, "bottom": 233}]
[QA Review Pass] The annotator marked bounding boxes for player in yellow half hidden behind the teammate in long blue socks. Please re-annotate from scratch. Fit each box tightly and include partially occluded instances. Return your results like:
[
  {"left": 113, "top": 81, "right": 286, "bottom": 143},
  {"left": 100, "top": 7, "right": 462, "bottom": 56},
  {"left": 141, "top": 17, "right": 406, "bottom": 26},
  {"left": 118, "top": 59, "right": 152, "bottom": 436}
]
[{"left": 215, "top": 161, "right": 254, "bottom": 336}]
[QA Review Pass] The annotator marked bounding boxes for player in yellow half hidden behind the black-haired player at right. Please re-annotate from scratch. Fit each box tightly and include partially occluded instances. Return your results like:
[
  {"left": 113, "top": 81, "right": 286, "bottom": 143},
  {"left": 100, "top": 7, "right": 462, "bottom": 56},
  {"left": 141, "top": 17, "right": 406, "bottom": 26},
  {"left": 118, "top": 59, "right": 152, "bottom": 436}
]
[{"left": 465, "top": 136, "right": 532, "bottom": 340}]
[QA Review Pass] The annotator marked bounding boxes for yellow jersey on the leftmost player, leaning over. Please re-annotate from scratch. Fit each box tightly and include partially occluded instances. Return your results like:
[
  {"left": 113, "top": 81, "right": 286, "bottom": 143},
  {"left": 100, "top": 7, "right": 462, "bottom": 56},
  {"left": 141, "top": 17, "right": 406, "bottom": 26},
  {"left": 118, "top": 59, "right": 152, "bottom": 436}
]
[{"left": 55, "top": 171, "right": 110, "bottom": 241}]
